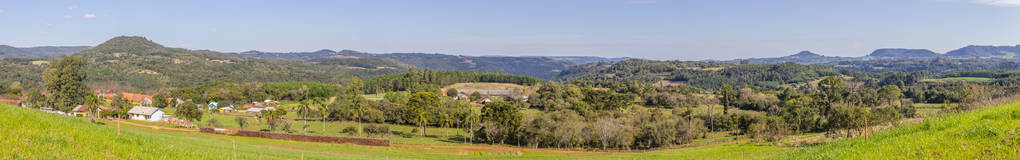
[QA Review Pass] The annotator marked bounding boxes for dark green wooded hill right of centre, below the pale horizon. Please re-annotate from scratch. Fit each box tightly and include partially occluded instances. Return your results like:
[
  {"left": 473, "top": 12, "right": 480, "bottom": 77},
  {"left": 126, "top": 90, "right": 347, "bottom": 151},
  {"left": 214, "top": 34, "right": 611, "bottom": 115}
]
[{"left": 559, "top": 59, "right": 843, "bottom": 89}]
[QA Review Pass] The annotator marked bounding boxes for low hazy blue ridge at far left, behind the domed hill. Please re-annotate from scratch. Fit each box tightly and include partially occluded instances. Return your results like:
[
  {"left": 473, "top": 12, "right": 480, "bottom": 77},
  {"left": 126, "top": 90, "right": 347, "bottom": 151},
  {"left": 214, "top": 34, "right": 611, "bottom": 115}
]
[{"left": 0, "top": 45, "right": 89, "bottom": 58}]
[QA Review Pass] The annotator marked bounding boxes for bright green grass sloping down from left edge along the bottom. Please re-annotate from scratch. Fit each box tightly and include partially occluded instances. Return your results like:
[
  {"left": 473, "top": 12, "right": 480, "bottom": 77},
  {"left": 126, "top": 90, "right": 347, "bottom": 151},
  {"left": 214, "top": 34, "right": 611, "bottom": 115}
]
[{"left": 0, "top": 104, "right": 791, "bottom": 159}]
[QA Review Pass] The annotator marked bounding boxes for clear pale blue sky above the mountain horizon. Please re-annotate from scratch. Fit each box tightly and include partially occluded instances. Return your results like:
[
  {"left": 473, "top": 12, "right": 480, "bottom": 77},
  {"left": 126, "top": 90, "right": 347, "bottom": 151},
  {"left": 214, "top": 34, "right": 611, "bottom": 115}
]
[{"left": 0, "top": 0, "right": 1020, "bottom": 60}]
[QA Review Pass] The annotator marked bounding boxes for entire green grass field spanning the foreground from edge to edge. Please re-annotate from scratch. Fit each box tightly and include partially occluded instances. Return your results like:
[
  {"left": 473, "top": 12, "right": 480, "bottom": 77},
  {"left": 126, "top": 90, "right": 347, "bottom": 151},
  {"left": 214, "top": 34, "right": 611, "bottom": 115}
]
[{"left": 0, "top": 103, "right": 1020, "bottom": 159}]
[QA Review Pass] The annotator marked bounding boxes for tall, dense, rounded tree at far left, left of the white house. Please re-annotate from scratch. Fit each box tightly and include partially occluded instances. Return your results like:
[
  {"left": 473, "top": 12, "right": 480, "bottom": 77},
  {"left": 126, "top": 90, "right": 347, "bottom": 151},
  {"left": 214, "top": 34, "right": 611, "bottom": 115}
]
[{"left": 43, "top": 56, "right": 92, "bottom": 112}]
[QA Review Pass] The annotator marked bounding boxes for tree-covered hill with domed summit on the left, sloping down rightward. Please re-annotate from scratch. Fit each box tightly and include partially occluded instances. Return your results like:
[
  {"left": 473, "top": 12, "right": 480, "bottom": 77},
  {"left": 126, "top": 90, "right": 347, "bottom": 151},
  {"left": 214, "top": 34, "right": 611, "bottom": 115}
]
[{"left": 0, "top": 37, "right": 407, "bottom": 90}]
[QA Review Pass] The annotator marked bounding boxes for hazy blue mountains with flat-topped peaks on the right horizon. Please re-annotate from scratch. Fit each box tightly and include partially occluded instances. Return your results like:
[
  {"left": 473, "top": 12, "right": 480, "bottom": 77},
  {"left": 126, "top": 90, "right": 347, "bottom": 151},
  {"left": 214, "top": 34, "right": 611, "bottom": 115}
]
[{"left": 709, "top": 45, "right": 1020, "bottom": 64}]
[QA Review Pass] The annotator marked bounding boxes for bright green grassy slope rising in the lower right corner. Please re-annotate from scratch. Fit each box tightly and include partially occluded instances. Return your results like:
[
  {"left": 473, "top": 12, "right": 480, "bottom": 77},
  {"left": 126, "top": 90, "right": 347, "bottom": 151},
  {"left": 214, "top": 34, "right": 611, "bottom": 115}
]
[{"left": 770, "top": 103, "right": 1020, "bottom": 159}]
